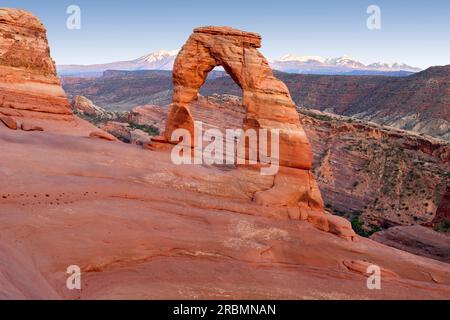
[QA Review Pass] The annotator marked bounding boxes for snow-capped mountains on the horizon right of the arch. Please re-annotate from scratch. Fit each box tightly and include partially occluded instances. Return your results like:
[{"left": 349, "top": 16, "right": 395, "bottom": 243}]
[{"left": 270, "top": 54, "right": 421, "bottom": 75}]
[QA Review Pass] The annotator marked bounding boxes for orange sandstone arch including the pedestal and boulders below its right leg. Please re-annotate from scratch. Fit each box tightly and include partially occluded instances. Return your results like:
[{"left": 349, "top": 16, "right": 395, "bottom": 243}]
[{"left": 160, "top": 27, "right": 354, "bottom": 239}]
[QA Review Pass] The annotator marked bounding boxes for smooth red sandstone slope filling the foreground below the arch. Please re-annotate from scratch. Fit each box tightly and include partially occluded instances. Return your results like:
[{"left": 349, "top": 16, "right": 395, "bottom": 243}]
[{"left": 0, "top": 126, "right": 450, "bottom": 299}]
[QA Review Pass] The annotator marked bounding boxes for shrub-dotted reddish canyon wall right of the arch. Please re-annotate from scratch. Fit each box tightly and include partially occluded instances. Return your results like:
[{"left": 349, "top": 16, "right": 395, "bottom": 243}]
[{"left": 300, "top": 109, "right": 450, "bottom": 231}]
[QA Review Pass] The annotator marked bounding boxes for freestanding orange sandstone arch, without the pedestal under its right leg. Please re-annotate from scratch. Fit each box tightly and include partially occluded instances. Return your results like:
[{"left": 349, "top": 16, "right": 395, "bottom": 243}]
[{"left": 165, "top": 27, "right": 312, "bottom": 170}]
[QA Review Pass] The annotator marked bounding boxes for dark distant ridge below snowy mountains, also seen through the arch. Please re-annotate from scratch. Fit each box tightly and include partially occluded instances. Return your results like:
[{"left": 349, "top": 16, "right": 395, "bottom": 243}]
[{"left": 62, "top": 66, "right": 450, "bottom": 141}]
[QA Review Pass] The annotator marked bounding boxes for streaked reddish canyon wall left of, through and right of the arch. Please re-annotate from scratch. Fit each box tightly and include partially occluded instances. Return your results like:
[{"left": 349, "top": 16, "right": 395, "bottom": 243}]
[{"left": 72, "top": 94, "right": 450, "bottom": 238}]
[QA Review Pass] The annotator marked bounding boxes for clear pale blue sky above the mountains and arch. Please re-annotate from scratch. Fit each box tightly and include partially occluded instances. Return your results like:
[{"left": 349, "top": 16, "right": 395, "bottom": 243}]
[{"left": 0, "top": 0, "right": 450, "bottom": 68}]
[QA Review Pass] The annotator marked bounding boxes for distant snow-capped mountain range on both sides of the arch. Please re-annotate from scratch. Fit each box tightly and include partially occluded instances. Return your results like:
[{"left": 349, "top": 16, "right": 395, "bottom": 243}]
[{"left": 57, "top": 50, "right": 421, "bottom": 76}]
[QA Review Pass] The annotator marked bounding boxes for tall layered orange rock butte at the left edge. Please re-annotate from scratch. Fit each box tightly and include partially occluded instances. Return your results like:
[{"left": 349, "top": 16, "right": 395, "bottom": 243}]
[{"left": 0, "top": 9, "right": 96, "bottom": 134}]
